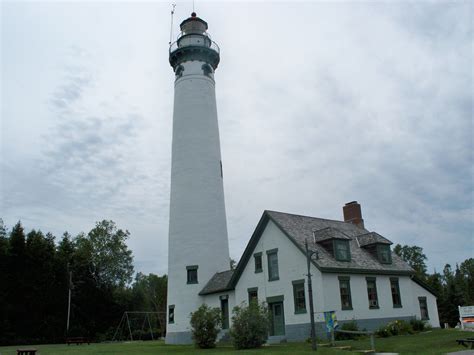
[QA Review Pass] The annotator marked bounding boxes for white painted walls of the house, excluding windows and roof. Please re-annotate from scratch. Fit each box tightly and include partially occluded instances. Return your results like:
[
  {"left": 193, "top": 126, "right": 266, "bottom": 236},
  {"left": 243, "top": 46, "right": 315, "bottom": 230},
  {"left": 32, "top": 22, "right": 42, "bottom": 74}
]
[{"left": 230, "top": 220, "right": 439, "bottom": 327}]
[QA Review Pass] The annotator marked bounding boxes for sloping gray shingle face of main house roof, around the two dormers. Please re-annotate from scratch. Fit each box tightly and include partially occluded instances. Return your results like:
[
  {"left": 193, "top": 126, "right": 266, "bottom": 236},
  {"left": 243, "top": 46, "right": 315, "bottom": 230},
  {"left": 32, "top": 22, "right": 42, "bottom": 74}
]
[{"left": 266, "top": 211, "right": 413, "bottom": 274}]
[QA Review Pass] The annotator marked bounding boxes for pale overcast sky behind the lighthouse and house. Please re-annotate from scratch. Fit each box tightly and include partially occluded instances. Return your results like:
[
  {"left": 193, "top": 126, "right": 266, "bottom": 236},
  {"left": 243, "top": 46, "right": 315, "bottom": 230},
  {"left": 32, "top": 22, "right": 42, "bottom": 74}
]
[{"left": 0, "top": 0, "right": 474, "bottom": 274}]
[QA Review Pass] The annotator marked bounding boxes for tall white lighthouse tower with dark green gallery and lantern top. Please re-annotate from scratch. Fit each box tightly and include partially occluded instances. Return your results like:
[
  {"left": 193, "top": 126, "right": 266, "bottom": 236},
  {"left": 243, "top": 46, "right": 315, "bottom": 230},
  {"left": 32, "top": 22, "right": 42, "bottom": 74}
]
[{"left": 166, "top": 12, "right": 230, "bottom": 344}]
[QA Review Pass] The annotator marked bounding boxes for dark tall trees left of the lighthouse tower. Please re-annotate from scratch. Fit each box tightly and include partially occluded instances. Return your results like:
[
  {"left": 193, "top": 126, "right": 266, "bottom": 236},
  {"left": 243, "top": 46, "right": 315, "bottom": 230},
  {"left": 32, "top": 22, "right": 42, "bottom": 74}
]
[{"left": 0, "top": 219, "right": 167, "bottom": 345}]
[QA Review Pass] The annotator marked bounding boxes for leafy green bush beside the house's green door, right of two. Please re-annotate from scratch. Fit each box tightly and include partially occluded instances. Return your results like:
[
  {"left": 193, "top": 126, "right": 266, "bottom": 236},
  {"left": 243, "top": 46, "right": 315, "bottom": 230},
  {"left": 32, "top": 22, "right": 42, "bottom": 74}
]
[{"left": 230, "top": 302, "right": 269, "bottom": 349}]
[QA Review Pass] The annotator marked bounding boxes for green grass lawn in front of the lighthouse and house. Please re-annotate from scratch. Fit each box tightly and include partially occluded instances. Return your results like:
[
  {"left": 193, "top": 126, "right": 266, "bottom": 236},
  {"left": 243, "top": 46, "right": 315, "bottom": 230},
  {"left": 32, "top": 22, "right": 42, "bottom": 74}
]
[{"left": 0, "top": 329, "right": 474, "bottom": 355}]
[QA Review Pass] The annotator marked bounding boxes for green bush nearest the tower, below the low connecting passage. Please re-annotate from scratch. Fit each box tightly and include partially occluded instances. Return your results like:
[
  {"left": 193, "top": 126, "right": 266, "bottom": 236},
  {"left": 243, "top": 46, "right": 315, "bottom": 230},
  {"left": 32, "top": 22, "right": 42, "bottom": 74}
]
[{"left": 191, "top": 304, "right": 222, "bottom": 349}]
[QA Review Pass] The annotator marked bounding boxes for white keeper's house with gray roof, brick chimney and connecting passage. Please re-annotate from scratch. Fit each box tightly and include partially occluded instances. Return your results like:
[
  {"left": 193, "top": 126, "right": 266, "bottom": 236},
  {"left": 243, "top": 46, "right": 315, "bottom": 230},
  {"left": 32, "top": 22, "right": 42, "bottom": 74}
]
[{"left": 199, "top": 202, "right": 440, "bottom": 341}]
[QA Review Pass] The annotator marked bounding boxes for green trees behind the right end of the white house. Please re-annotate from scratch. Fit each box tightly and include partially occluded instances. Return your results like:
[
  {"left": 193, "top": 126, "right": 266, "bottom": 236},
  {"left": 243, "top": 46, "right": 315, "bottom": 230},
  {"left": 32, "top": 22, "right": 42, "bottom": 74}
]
[{"left": 394, "top": 244, "right": 474, "bottom": 327}]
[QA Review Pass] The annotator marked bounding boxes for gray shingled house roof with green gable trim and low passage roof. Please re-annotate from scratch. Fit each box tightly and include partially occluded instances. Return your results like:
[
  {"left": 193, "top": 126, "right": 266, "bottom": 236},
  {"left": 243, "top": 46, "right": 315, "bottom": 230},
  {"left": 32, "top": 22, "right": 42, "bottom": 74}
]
[{"left": 204, "top": 211, "right": 414, "bottom": 295}]
